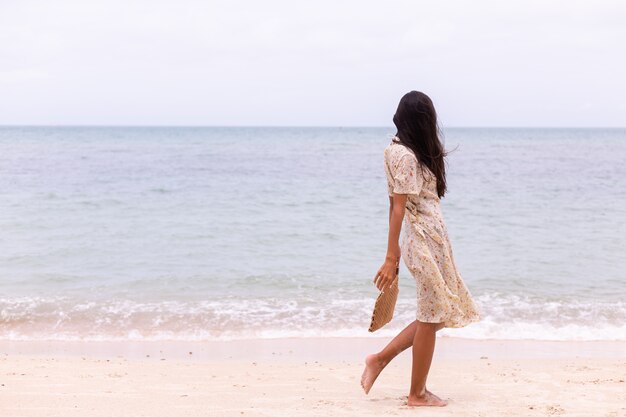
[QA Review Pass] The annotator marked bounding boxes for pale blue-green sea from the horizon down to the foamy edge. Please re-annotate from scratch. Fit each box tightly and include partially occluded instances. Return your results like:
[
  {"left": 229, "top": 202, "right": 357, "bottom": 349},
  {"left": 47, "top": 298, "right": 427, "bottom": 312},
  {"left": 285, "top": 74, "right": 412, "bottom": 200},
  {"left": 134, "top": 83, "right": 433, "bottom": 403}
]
[{"left": 0, "top": 127, "right": 626, "bottom": 340}]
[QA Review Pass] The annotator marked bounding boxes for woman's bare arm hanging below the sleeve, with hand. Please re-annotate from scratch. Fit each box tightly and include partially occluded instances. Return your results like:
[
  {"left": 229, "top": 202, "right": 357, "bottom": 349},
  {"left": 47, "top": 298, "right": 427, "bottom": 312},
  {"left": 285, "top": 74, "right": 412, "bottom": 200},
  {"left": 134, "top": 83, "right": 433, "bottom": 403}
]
[{"left": 374, "top": 193, "right": 407, "bottom": 291}]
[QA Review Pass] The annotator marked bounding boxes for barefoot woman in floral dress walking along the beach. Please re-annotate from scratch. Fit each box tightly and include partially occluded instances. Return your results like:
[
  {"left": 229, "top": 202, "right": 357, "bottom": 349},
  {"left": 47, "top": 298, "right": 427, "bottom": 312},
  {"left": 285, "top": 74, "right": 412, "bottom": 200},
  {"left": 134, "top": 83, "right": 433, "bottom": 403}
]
[{"left": 361, "top": 91, "right": 480, "bottom": 406}]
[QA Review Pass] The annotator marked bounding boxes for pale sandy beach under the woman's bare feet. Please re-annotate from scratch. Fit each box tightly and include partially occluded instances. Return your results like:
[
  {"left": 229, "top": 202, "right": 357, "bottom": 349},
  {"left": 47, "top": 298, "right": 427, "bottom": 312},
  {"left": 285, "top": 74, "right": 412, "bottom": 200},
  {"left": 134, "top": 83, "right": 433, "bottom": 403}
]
[{"left": 0, "top": 337, "right": 626, "bottom": 417}]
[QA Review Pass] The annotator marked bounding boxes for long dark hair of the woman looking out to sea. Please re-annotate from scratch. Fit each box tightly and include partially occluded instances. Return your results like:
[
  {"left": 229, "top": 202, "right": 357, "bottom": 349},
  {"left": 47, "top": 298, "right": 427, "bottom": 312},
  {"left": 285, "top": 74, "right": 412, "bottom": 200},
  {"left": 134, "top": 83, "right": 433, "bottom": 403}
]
[{"left": 393, "top": 91, "right": 448, "bottom": 198}]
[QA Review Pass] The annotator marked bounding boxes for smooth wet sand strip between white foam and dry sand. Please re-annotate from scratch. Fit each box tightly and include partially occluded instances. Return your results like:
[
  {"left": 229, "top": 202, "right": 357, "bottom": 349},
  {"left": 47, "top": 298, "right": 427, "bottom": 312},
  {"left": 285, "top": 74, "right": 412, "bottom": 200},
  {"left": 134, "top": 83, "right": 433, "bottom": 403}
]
[{"left": 0, "top": 336, "right": 626, "bottom": 361}]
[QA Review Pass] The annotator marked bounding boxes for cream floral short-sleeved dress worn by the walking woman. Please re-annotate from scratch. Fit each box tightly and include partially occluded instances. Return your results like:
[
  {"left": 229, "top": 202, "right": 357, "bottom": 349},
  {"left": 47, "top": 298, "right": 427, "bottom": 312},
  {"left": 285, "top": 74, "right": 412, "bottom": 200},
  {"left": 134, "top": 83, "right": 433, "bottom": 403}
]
[{"left": 384, "top": 136, "right": 481, "bottom": 327}]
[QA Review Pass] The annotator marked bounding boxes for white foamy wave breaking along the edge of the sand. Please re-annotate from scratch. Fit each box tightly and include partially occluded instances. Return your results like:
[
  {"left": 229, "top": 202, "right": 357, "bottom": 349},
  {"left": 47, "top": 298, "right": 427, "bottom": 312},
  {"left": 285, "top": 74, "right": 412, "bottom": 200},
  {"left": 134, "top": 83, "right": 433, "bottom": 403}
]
[{"left": 0, "top": 292, "right": 626, "bottom": 341}]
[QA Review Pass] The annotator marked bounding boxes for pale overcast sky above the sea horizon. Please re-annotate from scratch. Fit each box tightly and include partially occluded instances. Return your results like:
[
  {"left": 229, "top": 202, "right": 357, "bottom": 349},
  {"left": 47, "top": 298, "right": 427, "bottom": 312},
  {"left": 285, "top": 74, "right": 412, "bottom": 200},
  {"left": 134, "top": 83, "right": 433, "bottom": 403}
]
[{"left": 0, "top": 0, "right": 626, "bottom": 127}]
